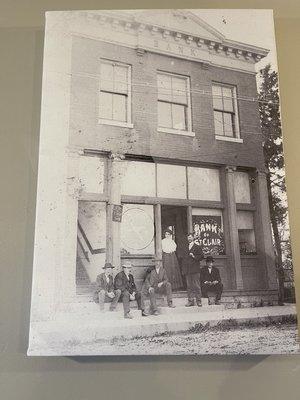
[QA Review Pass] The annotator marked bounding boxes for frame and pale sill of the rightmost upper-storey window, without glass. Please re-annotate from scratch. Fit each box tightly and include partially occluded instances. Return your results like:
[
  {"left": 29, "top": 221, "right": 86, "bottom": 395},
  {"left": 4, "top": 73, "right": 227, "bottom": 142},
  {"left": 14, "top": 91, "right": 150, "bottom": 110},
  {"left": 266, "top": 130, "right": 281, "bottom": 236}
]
[{"left": 212, "top": 81, "right": 243, "bottom": 143}]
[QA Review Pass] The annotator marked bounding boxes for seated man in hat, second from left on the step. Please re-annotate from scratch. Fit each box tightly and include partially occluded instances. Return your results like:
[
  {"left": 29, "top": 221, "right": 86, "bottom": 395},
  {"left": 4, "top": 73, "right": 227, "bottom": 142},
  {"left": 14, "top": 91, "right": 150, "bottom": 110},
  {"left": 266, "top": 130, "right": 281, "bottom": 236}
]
[{"left": 115, "top": 261, "right": 147, "bottom": 319}]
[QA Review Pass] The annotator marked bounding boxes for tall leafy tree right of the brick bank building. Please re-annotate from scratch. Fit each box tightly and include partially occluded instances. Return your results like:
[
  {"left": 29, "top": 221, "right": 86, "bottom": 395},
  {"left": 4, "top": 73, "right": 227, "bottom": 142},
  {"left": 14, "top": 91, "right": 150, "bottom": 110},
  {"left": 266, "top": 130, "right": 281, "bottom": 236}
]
[{"left": 259, "top": 64, "right": 287, "bottom": 303}]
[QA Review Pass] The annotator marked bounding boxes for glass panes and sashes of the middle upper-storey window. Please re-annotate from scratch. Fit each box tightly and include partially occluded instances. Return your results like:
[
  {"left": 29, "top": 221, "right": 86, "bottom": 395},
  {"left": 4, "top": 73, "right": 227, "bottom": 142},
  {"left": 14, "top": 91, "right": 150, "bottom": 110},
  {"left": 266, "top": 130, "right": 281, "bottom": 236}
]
[{"left": 157, "top": 72, "right": 191, "bottom": 133}]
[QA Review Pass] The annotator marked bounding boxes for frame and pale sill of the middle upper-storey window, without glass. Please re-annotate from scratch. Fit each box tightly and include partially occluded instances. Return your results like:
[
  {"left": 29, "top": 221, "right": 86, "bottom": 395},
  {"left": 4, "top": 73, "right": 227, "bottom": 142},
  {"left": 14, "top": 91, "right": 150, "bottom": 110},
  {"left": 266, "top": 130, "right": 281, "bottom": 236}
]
[{"left": 156, "top": 70, "right": 195, "bottom": 136}]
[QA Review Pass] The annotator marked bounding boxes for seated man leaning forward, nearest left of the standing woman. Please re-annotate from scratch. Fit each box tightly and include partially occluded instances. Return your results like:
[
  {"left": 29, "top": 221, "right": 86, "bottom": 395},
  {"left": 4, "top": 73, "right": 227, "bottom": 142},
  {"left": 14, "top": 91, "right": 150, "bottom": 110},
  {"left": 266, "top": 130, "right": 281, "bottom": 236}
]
[{"left": 141, "top": 258, "right": 175, "bottom": 315}]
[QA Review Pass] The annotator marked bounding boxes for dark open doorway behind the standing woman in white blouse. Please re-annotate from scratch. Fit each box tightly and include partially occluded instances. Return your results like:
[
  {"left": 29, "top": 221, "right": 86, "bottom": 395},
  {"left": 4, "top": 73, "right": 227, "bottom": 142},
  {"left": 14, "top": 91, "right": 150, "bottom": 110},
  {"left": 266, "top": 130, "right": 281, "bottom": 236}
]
[{"left": 161, "top": 205, "right": 188, "bottom": 291}]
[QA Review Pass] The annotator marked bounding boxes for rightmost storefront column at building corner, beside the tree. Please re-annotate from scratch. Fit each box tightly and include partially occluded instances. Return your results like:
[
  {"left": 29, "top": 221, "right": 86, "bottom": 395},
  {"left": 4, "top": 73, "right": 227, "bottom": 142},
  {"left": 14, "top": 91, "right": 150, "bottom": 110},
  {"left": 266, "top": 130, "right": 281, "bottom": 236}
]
[{"left": 255, "top": 171, "right": 278, "bottom": 290}]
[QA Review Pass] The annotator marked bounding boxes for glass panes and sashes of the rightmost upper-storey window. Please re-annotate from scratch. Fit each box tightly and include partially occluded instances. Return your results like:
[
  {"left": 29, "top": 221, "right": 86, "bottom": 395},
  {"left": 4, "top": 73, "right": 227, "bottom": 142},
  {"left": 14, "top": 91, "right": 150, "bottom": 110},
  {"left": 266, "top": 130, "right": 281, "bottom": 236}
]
[{"left": 212, "top": 83, "right": 240, "bottom": 140}]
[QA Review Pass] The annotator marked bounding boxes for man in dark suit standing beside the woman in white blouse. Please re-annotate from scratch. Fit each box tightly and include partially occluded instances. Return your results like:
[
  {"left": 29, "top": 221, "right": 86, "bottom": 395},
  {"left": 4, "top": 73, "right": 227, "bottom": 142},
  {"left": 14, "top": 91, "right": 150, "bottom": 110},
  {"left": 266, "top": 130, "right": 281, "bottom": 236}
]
[{"left": 182, "top": 233, "right": 204, "bottom": 307}]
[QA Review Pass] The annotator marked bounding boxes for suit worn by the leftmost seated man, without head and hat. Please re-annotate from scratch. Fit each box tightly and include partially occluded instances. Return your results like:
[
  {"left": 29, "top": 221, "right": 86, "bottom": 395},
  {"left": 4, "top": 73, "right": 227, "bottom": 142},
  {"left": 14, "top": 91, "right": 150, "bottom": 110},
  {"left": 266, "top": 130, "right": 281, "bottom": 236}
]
[{"left": 94, "top": 272, "right": 121, "bottom": 310}]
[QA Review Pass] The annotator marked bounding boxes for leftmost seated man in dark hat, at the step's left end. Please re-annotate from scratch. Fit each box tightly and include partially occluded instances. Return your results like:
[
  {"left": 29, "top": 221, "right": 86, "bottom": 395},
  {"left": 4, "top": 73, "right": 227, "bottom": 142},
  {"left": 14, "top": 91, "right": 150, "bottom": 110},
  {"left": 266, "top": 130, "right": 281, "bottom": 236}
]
[{"left": 94, "top": 263, "right": 121, "bottom": 311}]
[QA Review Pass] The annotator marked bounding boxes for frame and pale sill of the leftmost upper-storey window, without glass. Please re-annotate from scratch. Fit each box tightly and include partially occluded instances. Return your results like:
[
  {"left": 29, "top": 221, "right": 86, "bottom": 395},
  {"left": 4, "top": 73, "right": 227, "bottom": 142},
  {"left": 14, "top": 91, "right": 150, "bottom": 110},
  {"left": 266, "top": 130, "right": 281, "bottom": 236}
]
[{"left": 98, "top": 58, "right": 133, "bottom": 128}]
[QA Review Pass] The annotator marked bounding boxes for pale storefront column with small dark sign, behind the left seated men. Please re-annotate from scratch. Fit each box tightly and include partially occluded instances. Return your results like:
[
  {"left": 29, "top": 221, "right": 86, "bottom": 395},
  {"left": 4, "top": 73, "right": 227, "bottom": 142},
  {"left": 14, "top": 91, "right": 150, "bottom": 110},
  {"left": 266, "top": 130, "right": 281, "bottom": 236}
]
[{"left": 107, "top": 153, "right": 125, "bottom": 272}]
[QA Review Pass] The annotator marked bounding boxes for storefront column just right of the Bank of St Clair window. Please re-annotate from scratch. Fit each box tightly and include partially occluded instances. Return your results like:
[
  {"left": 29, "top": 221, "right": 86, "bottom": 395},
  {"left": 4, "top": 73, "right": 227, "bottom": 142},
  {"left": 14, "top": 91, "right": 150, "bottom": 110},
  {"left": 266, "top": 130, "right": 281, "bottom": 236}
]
[{"left": 225, "top": 166, "right": 244, "bottom": 289}]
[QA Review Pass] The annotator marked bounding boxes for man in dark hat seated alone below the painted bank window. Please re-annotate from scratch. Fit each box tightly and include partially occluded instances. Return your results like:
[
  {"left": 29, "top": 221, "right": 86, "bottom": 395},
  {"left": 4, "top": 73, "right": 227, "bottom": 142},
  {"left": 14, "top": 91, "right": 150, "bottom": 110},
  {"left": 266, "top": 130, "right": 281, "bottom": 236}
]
[{"left": 200, "top": 256, "right": 223, "bottom": 304}]
